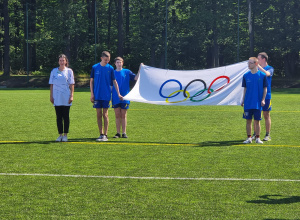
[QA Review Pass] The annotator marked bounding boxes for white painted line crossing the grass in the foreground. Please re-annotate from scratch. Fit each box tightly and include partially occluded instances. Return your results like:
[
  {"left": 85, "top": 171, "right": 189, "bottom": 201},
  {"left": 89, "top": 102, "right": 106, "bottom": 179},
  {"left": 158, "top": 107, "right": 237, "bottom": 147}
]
[{"left": 0, "top": 173, "right": 300, "bottom": 182}]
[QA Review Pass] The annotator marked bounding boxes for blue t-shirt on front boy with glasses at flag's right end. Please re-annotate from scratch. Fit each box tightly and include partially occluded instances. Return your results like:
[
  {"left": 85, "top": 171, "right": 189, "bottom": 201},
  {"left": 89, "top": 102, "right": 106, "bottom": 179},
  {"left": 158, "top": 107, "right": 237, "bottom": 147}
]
[{"left": 242, "top": 71, "right": 268, "bottom": 110}]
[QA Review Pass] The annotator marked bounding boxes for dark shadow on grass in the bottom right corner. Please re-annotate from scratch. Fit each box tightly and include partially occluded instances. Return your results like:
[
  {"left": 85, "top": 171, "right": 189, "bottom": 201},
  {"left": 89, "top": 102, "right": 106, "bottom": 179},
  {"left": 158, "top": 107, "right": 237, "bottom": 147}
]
[{"left": 247, "top": 195, "right": 300, "bottom": 205}]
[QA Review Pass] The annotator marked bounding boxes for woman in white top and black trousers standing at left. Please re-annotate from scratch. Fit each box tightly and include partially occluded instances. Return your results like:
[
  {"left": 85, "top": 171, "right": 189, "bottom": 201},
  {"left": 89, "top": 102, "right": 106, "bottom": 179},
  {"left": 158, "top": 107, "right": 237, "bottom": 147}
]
[{"left": 49, "top": 54, "right": 75, "bottom": 142}]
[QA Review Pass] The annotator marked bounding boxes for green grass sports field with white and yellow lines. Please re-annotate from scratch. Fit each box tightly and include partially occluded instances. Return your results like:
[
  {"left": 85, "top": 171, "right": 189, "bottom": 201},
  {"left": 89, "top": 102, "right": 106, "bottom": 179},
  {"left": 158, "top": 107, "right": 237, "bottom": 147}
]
[{"left": 0, "top": 89, "right": 300, "bottom": 220}]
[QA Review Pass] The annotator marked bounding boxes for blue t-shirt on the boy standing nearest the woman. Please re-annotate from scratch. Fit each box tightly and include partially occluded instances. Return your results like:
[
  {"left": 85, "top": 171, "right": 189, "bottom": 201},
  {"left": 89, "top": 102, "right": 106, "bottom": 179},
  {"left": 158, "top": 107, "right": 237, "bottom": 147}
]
[{"left": 91, "top": 63, "right": 115, "bottom": 101}]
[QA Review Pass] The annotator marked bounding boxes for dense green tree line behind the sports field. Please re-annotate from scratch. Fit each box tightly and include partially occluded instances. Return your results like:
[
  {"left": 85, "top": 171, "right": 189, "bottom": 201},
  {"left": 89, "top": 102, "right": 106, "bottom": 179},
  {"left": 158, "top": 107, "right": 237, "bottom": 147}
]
[{"left": 0, "top": 0, "right": 300, "bottom": 78}]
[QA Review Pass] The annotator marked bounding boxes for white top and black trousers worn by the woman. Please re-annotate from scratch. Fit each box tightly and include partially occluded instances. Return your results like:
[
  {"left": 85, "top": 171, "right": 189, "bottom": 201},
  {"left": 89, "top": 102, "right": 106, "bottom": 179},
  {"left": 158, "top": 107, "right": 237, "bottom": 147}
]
[{"left": 49, "top": 67, "right": 75, "bottom": 134}]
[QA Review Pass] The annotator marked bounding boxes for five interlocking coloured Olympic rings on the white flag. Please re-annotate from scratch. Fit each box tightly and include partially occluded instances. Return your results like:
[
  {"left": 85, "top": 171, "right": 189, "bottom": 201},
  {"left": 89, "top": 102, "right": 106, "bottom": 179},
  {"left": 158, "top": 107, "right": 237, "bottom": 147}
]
[{"left": 159, "top": 76, "right": 230, "bottom": 103}]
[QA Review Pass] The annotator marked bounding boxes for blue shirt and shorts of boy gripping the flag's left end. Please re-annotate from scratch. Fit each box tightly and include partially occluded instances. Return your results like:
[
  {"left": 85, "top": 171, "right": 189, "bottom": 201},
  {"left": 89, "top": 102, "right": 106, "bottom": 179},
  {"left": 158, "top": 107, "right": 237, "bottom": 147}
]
[{"left": 112, "top": 69, "right": 135, "bottom": 105}]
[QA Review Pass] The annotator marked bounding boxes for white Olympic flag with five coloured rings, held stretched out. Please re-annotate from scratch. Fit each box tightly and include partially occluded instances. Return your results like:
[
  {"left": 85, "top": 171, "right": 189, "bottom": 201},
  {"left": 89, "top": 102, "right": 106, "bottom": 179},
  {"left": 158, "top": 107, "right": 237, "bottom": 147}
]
[{"left": 124, "top": 61, "right": 249, "bottom": 105}]
